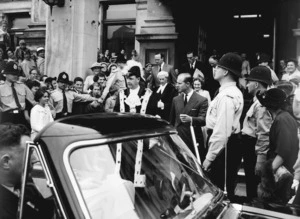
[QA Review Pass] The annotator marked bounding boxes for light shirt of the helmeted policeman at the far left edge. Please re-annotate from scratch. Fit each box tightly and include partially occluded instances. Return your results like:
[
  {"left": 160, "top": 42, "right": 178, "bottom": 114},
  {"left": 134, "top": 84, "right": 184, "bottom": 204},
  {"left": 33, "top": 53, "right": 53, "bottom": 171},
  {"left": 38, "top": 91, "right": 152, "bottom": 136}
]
[{"left": 0, "top": 81, "right": 35, "bottom": 112}]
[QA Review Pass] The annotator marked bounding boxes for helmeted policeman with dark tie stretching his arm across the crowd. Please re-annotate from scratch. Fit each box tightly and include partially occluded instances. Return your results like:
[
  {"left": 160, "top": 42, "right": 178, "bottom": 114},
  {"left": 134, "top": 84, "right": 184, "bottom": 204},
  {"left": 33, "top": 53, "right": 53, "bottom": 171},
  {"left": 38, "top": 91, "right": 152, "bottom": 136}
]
[{"left": 49, "top": 72, "right": 98, "bottom": 119}]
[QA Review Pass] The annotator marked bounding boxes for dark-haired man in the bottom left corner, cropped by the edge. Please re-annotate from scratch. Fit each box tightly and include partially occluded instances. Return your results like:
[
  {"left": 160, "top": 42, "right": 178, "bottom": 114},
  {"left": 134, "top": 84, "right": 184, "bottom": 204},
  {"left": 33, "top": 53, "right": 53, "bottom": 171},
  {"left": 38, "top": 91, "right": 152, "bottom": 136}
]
[{"left": 0, "top": 124, "right": 54, "bottom": 219}]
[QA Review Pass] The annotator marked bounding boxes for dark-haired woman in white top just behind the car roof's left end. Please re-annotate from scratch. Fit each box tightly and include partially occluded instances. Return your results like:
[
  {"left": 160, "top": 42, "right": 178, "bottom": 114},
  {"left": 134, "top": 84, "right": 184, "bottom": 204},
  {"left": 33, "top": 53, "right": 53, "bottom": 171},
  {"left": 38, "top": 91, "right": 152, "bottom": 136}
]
[{"left": 30, "top": 88, "right": 54, "bottom": 140}]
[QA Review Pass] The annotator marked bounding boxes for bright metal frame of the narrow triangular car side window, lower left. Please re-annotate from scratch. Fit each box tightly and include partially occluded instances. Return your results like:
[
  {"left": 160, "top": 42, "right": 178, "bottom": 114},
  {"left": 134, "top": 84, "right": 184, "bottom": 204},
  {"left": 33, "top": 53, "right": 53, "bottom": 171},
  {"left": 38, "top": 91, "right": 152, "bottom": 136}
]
[{"left": 18, "top": 141, "right": 67, "bottom": 219}]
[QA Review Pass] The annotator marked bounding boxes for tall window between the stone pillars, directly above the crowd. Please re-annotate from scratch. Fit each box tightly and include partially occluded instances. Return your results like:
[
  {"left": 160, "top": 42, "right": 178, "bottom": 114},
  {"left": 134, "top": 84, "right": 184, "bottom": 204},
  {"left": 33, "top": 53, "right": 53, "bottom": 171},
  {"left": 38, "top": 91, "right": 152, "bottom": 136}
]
[{"left": 102, "top": 4, "right": 136, "bottom": 57}]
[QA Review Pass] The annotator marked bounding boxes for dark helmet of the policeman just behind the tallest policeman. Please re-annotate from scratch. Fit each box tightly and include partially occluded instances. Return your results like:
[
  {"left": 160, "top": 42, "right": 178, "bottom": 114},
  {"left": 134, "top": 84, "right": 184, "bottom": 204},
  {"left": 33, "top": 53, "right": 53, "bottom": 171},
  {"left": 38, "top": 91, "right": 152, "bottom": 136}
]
[{"left": 246, "top": 66, "right": 272, "bottom": 85}]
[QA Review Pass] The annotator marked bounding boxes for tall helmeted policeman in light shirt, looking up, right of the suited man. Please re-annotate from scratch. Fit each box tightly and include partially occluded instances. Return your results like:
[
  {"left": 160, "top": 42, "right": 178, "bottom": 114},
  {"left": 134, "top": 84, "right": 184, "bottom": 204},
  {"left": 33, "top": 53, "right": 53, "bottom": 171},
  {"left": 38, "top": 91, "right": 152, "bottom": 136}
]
[{"left": 203, "top": 53, "right": 244, "bottom": 199}]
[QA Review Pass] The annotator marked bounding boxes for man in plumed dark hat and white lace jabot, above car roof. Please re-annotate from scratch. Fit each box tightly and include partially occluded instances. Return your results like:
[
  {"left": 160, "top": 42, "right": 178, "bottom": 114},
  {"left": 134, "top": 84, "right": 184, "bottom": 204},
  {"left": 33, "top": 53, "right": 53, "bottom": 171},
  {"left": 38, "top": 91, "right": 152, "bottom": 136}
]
[{"left": 114, "top": 66, "right": 145, "bottom": 113}]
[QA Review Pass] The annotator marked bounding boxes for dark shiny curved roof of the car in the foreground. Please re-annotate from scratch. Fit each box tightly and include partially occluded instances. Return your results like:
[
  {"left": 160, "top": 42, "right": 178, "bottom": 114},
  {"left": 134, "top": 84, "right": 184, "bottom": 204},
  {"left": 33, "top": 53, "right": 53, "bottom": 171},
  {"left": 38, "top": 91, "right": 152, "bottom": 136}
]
[{"left": 34, "top": 113, "right": 176, "bottom": 151}]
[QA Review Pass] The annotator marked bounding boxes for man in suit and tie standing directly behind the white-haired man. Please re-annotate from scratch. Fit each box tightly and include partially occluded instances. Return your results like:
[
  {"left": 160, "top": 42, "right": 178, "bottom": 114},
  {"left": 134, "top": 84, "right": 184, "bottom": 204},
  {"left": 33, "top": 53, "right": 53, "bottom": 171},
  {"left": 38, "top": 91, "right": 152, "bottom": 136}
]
[{"left": 150, "top": 53, "right": 176, "bottom": 89}]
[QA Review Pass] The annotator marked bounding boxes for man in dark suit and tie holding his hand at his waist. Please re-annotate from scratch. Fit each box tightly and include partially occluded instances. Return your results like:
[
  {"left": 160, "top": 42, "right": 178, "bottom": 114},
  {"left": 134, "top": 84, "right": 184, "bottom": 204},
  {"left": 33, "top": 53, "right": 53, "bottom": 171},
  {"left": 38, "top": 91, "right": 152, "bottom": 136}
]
[{"left": 170, "top": 73, "right": 208, "bottom": 161}]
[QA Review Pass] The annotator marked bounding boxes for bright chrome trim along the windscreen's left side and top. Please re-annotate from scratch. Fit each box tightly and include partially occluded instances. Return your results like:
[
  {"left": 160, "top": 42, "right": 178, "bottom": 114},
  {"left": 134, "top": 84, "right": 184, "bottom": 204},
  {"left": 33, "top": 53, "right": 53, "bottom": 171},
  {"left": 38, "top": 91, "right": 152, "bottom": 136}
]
[{"left": 63, "top": 131, "right": 177, "bottom": 219}]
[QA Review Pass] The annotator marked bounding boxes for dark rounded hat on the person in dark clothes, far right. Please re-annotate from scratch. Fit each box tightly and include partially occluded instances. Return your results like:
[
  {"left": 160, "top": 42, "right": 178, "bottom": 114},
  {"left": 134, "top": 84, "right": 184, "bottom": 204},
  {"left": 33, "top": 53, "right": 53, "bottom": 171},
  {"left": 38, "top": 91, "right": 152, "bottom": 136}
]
[{"left": 256, "top": 88, "right": 287, "bottom": 110}]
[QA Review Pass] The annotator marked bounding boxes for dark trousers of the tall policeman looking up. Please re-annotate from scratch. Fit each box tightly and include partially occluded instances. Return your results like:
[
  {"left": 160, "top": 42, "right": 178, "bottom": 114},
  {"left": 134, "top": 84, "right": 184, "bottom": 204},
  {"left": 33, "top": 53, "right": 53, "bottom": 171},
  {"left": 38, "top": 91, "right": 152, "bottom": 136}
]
[{"left": 208, "top": 132, "right": 241, "bottom": 199}]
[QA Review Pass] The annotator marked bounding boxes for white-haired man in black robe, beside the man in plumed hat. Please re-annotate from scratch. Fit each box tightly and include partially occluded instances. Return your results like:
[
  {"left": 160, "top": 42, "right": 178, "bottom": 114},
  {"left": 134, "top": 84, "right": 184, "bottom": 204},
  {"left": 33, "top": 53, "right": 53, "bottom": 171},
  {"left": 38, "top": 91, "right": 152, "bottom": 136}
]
[{"left": 146, "top": 71, "right": 177, "bottom": 121}]
